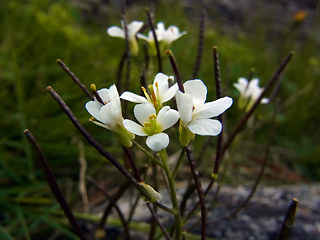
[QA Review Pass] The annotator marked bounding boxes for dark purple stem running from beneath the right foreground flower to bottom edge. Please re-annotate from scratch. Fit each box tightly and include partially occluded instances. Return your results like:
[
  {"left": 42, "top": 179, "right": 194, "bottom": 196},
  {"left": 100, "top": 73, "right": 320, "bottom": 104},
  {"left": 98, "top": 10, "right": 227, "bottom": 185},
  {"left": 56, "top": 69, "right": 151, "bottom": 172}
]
[{"left": 186, "top": 146, "right": 207, "bottom": 240}]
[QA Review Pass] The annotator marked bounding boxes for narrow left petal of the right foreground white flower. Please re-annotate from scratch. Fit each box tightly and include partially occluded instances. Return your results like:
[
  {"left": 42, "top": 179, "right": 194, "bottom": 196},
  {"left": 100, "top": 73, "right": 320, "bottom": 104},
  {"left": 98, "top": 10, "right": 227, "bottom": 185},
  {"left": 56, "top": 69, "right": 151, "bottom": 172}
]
[{"left": 176, "top": 91, "right": 193, "bottom": 124}]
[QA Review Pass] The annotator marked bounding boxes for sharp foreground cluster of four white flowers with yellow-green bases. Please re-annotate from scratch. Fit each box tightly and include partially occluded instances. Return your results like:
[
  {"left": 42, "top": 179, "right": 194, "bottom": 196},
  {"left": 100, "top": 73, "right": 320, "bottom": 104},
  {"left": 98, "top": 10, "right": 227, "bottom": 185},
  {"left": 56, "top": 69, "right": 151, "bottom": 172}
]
[{"left": 86, "top": 73, "right": 232, "bottom": 152}]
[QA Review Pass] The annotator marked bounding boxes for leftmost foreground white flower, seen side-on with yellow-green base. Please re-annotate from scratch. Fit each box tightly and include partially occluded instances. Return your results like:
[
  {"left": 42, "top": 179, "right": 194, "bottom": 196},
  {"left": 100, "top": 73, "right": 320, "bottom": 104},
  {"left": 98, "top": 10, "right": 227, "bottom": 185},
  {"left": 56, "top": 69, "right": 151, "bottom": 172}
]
[{"left": 86, "top": 84, "right": 134, "bottom": 147}]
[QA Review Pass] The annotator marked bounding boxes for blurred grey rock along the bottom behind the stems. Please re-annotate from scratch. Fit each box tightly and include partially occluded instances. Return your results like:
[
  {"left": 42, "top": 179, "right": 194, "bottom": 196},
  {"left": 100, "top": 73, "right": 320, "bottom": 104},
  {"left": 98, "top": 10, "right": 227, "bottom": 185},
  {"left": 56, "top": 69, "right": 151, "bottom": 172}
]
[{"left": 99, "top": 184, "right": 320, "bottom": 240}]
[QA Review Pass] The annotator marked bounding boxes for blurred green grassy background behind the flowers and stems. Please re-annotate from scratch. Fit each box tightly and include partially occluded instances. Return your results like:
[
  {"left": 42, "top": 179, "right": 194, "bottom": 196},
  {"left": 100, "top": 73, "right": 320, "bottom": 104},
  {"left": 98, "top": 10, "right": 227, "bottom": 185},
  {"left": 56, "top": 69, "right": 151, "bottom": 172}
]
[{"left": 0, "top": 0, "right": 320, "bottom": 239}]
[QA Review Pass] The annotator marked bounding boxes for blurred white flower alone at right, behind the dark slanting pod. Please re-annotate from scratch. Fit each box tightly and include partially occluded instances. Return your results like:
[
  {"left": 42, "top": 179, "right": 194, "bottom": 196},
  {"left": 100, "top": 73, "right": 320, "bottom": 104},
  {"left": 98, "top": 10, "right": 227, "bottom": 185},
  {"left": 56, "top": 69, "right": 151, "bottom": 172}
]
[{"left": 233, "top": 77, "right": 269, "bottom": 111}]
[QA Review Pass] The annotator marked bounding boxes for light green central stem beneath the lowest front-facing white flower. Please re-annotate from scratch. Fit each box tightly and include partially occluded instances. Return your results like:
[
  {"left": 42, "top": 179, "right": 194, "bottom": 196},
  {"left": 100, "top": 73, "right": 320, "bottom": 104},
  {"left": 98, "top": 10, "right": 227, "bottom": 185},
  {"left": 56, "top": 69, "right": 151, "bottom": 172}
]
[{"left": 159, "top": 149, "right": 182, "bottom": 240}]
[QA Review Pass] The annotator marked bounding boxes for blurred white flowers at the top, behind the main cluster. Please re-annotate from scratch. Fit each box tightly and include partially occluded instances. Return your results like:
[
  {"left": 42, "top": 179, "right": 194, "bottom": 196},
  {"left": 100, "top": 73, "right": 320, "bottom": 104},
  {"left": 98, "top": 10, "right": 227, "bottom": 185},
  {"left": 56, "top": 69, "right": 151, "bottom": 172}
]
[{"left": 107, "top": 21, "right": 187, "bottom": 56}]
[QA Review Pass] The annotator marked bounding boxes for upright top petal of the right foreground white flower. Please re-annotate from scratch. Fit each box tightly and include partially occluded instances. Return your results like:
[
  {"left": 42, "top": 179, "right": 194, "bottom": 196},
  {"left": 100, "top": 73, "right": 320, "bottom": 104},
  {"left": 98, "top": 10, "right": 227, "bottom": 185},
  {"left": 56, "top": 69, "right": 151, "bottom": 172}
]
[{"left": 183, "top": 79, "right": 207, "bottom": 105}]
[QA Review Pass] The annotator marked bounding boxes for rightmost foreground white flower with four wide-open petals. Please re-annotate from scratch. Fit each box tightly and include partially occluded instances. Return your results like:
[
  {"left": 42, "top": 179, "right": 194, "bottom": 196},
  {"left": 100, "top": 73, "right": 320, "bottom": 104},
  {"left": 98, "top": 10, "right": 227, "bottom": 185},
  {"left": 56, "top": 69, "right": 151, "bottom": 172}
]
[{"left": 176, "top": 79, "right": 232, "bottom": 136}]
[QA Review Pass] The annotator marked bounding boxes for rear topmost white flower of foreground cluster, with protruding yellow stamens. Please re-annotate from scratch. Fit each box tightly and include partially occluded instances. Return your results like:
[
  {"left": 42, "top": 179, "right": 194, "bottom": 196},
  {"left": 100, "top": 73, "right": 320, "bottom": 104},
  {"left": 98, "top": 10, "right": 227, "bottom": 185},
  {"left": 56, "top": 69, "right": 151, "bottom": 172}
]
[{"left": 120, "top": 73, "right": 178, "bottom": 112}]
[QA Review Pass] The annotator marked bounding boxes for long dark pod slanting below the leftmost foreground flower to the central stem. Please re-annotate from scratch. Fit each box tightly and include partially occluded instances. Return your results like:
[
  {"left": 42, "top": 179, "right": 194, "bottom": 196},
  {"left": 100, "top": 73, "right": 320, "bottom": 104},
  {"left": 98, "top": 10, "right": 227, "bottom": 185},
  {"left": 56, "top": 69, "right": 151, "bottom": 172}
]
[{"left": 47, "top": 86, "right": 173, "bottom": 213}]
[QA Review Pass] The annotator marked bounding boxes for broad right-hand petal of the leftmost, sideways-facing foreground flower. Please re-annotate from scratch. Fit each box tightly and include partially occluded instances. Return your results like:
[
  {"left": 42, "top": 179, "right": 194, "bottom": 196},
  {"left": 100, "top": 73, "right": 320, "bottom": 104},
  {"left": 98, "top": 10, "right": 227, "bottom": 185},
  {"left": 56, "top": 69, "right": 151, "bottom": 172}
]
[{"left": 100, "top": 102, "right": 123, "bottom": 128}]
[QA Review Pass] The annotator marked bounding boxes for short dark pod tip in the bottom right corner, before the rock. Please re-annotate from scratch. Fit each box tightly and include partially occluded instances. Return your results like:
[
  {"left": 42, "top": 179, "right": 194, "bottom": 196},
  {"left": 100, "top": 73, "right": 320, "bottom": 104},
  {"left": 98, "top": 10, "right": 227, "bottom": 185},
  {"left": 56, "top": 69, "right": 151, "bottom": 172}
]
[{"left": 276, "top": 198, "right": 298, "bottom": 240}]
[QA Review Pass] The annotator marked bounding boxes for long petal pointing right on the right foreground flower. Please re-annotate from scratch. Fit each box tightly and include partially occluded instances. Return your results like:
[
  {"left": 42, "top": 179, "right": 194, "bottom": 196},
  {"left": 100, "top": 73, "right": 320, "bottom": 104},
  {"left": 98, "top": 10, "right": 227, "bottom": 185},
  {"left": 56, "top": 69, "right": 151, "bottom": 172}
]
[{"left": 193, "top": 97, "right": 232, "bottom": 119}]
